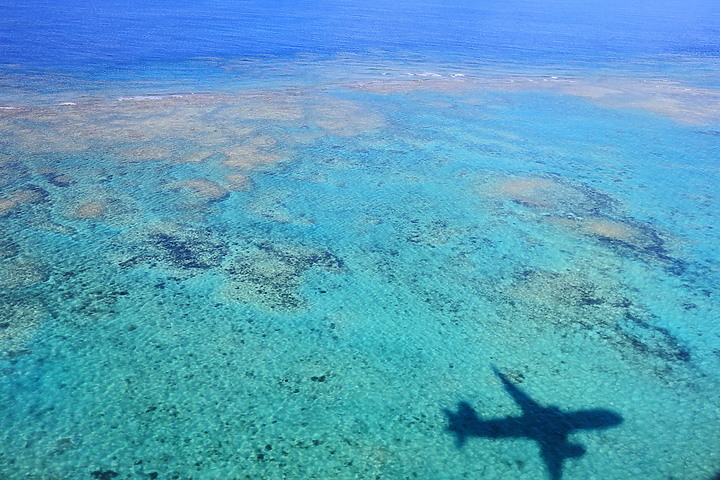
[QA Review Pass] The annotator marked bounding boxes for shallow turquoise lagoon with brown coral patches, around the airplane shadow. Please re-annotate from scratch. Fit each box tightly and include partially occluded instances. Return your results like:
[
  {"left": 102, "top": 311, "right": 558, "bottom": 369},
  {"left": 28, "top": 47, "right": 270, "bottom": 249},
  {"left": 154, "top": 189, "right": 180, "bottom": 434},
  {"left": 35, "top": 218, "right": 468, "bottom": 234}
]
[{"left": 0, "top": 55, "right": 719, "bottom": 478}]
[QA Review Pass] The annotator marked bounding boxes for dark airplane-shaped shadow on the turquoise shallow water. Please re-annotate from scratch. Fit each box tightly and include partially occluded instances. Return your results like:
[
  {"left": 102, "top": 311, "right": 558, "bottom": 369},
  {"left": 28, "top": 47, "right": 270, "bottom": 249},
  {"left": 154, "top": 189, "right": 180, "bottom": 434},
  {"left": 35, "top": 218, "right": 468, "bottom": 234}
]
[{"left": 443, "top": 367, "right": 623, "bottom": 480}]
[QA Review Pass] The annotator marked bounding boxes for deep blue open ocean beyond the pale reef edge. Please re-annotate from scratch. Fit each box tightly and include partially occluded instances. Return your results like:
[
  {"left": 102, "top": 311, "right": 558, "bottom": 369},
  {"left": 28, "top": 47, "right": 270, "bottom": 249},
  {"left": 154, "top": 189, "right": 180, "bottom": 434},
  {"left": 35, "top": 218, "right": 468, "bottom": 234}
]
[{"left": 0, "top": 0, "right": 720, "bottom": 70}]
